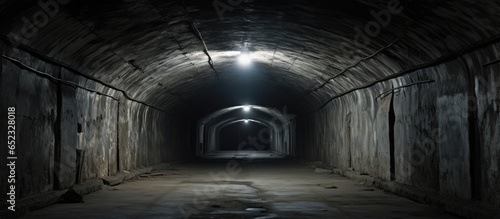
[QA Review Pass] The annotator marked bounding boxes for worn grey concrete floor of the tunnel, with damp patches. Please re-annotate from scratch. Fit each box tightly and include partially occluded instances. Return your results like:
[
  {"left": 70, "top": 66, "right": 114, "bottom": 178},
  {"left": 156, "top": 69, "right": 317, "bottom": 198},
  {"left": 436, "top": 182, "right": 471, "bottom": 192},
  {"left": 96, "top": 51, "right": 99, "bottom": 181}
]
[{"left": 21, "top": 153, "right": 456, "bottom": 219}]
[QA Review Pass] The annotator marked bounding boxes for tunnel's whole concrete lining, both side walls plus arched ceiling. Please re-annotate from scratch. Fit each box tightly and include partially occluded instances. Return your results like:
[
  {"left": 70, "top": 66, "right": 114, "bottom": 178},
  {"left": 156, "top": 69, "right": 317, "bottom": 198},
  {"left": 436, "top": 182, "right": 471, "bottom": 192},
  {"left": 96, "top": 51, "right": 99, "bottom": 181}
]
[{"left": 0, "top": 0, "right": 500, "bottom": 210}]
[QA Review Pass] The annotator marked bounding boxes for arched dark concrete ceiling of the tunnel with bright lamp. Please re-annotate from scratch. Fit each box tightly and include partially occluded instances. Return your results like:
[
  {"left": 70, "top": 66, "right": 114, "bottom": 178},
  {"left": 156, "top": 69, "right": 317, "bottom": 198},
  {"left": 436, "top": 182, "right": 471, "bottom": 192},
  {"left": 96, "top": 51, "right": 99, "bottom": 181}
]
[{"left": 0, "top": 0, "right": 500, "bottom": 116}]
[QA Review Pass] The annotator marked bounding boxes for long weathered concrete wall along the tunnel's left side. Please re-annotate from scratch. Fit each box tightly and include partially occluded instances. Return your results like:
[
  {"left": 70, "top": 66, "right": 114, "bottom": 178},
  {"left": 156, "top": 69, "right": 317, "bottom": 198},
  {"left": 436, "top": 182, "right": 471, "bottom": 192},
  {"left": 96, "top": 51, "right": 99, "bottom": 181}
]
[{"left": 0, "top": 44, "right": 190, "bottom": 199}]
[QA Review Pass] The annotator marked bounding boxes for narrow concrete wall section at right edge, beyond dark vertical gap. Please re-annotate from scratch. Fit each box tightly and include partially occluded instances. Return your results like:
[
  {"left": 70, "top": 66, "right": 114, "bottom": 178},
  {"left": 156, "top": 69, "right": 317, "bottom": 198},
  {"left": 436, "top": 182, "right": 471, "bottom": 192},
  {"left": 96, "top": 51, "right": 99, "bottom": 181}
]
[{"left": 466, "top": 44, "right": 500, "bottom": 203}]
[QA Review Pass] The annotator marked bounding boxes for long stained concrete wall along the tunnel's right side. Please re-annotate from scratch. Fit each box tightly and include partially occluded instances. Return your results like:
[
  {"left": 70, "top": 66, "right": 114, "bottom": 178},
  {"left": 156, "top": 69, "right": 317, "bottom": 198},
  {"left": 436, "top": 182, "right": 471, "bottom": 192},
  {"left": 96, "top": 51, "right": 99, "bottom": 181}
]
[{"left": 297, "top": 42, "right": 500, "bottom": 204}]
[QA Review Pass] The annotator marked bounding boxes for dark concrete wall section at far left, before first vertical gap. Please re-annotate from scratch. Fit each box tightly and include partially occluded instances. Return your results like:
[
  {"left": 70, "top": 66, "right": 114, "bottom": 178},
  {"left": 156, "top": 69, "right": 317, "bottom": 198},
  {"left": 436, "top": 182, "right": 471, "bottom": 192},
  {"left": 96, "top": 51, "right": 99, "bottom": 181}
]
[{"left": 0, "top": 50, "right": 60, "bottom": 198}]
